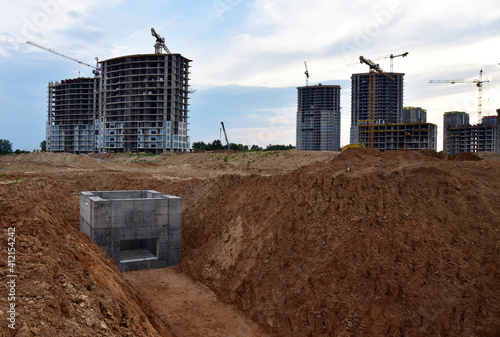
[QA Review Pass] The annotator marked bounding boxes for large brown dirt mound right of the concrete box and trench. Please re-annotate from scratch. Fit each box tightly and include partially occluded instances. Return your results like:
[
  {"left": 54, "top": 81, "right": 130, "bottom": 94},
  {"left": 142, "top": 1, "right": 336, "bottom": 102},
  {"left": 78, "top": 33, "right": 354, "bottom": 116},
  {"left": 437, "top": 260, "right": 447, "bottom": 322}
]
[{"left": 181, "top": 150, "right": 500, "bottom": 336}]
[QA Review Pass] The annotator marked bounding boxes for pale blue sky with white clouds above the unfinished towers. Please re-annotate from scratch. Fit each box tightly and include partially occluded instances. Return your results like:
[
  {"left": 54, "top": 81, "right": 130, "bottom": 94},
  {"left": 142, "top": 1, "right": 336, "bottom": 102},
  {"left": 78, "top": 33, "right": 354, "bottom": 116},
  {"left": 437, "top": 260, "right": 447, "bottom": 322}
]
[{"left": 0, "top": 0, "right": 500, "bottom": 150}]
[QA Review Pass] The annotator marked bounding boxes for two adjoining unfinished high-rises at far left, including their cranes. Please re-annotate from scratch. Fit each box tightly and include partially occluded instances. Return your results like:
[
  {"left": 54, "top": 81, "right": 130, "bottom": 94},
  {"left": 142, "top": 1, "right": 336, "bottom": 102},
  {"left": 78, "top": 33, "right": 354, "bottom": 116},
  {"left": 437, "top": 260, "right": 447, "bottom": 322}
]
[{"left": 44, "top": 29, "right": 191, "bottom": 154}]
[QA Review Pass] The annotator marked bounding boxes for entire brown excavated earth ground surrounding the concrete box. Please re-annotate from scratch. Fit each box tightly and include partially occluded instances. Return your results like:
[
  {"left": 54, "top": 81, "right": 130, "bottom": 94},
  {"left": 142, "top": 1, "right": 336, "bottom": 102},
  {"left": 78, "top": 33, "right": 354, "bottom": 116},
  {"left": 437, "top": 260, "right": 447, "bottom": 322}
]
[{"left": 0, "top": 149, "right": 500, "bottom": 337}]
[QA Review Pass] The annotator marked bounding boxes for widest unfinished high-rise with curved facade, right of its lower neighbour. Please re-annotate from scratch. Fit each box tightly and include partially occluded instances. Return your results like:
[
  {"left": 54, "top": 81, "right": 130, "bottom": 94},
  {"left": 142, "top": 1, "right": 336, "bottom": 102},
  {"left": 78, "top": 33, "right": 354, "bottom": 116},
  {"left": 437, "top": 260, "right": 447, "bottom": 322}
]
[{"left": 98, "top": 54, "right": 191, "bottom": 153}]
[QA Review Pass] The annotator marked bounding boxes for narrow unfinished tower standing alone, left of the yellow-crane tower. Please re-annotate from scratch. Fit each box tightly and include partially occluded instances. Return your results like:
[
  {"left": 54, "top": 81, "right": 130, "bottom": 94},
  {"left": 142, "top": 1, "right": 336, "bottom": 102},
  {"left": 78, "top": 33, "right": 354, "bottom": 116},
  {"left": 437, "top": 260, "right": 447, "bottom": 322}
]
[{"left": 296, "top": 84, "right": 340, "bottom": 151}]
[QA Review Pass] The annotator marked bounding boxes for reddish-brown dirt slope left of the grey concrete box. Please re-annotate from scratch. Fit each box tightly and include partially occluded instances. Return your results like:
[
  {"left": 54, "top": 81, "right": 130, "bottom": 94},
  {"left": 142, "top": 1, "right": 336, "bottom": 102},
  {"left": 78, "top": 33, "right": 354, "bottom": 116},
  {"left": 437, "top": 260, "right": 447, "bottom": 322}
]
[{"left": 0, "top": 174, "right": 174, "bottom": 336}]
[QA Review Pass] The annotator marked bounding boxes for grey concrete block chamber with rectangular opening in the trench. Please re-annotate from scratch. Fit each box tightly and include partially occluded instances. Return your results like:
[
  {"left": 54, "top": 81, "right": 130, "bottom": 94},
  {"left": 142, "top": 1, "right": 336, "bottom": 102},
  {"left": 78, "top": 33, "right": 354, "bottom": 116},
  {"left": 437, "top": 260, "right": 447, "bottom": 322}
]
[{"left": 80, "top": 191, "right": 182, "bottom": 271}]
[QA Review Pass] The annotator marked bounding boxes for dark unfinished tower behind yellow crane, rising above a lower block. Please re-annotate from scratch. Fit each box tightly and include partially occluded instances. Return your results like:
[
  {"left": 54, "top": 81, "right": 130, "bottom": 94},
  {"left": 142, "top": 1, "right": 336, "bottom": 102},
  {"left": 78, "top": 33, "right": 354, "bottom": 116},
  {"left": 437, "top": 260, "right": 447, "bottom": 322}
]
[{"left": 350, "top": 73, "right": 404, "bottom": 144}]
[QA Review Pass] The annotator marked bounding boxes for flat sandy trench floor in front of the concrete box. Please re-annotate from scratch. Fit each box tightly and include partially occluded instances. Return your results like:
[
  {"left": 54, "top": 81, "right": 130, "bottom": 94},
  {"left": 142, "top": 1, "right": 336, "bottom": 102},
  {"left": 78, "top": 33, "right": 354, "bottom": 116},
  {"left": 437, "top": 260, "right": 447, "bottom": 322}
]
[{"left": 124, "top": 267, "right": 271, "bottom": 337}]
